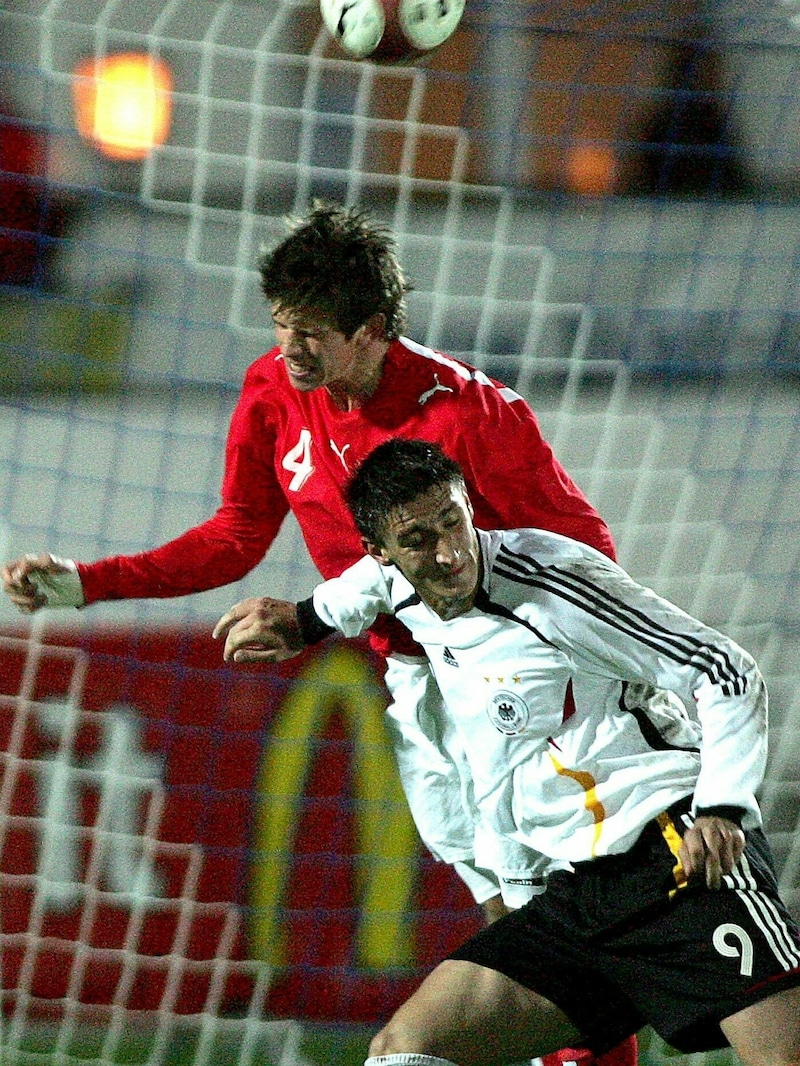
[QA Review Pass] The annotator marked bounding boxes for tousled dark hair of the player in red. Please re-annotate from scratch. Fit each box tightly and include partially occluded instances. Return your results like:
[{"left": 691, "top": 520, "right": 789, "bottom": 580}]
[{"left": 258, "top": 200, "right": 410, "bottom": 340}]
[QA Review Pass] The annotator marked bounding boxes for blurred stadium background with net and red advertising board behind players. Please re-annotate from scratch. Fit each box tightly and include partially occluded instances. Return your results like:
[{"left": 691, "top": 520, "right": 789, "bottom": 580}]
[{"left": 0, "top": 0, "right": 800, "bottom": 1066}]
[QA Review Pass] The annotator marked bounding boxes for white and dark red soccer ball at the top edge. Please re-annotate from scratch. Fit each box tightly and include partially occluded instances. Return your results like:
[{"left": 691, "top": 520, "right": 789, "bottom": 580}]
[{"left": 320, "top": 0, "right": 465, "bottom": 63}]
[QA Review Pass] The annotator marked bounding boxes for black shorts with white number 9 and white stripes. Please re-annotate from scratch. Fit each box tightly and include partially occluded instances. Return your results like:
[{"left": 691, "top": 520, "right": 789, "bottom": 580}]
[{"left": 450, "top": 807, "right": 800, "bottom": 1054}]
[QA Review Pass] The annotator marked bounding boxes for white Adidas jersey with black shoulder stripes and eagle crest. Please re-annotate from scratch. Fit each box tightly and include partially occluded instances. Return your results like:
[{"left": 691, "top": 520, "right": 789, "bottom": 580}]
[{"left": 311, "top": 529, "right": 767, "bottom": 894}]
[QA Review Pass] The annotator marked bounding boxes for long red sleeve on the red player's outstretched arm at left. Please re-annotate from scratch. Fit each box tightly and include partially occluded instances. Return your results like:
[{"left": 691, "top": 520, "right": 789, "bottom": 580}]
[{"left": 78, "top": 368, "right": 289, "bottom": 603}]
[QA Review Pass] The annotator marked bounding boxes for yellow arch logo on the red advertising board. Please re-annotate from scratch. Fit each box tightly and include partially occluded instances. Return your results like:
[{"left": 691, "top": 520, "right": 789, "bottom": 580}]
[{"left": 250, "top": 645, "right": 417, "bottom": 969}]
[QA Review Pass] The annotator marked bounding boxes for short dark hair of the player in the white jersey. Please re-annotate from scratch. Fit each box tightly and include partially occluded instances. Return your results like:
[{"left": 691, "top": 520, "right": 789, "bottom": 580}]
[{"left": 345, "top": 437, "right": 464, "bottom": 546}]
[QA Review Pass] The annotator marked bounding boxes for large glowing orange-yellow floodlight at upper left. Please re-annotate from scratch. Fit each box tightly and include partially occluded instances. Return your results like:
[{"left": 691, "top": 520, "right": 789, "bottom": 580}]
[{"left": 73, "top": 52, "right": 173, "bottom": 160}]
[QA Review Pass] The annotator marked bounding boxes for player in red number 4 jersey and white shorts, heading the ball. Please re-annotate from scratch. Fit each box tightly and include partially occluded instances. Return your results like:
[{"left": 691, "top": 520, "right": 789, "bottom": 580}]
[{"left": 2, "top": 205, "right": 636, "bottom": 1062}]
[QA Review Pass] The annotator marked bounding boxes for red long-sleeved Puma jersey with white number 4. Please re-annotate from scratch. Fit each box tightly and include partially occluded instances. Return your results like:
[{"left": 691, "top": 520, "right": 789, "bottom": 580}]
[{"left": 78, "top": 339, "right": 613, "bottom": 652}]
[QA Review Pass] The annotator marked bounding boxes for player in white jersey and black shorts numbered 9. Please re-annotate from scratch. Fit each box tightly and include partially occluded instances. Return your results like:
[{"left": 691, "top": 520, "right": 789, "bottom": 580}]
[{"left": 215, "top": 440, "right": 800, "bottom": 1066}]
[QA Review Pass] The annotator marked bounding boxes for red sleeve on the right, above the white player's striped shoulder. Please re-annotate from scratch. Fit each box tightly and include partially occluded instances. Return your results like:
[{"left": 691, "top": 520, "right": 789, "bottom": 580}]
[{"left": 448, "top": 377, "right": 615, "bottom": 559}]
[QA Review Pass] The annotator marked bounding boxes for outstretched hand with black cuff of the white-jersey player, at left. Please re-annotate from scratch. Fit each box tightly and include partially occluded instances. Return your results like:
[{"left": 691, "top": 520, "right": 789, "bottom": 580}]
[{"left": 213, "top": 596, "right": 305, "bottom": 663}]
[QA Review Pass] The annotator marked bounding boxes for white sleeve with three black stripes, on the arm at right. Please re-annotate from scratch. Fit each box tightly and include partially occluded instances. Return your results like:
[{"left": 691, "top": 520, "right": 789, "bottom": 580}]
[{"left": 537, "top": 560, "right": 767, "bottom": 828}]
